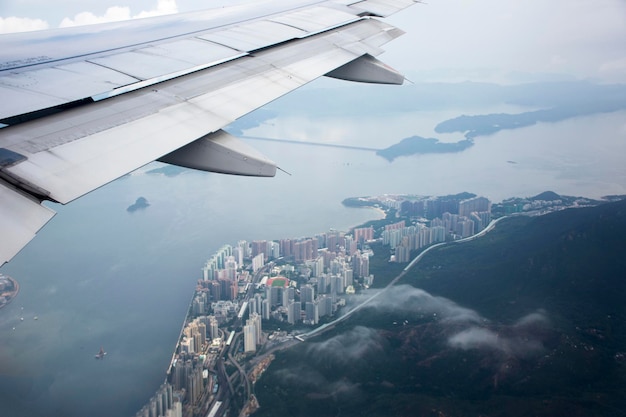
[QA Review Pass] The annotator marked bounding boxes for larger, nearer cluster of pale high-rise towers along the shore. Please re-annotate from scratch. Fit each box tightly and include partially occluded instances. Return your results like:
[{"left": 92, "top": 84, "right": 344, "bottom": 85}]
[{"left": 137, "top": 227, "right": 374, "bottom": 417}]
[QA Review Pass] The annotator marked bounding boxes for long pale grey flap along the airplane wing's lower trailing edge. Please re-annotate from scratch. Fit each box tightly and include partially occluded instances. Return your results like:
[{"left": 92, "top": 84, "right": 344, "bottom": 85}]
[{"left": 0, "top": 20, "right": 400, "bottom": 203}]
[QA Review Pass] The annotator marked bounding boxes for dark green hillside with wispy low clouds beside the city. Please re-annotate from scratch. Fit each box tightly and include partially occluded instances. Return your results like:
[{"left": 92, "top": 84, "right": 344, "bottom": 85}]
[{"left": 256, "top": 201, "right": 626, "bottom": 417}]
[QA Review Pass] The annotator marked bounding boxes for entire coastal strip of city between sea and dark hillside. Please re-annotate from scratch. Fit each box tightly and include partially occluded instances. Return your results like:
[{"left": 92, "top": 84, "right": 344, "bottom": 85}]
[{"left": 136, "top": 193, "right": 591, "bottom": 417}]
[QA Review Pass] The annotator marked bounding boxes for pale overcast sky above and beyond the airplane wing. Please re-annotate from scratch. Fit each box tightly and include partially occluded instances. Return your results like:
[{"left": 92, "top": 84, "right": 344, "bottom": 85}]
[{"left": 0, "top": 0, "right": 626, "bottom": 82}]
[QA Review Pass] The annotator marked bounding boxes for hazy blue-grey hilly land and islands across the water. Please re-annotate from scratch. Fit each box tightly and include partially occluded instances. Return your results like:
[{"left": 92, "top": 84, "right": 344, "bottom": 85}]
[{"left": 249, "top": 81, "right": 626, "bottom": 163}]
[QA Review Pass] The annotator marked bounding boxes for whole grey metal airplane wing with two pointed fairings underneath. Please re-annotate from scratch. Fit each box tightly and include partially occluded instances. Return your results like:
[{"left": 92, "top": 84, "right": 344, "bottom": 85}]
[{"left": 0, "top": 0, "right": 416, "bottom": 265}]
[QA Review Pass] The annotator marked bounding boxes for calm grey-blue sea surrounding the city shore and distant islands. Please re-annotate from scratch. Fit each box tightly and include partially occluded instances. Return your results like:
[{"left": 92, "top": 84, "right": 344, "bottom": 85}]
[{"left": 0, "top": 85, "right": 626, "bottom": 417}]
